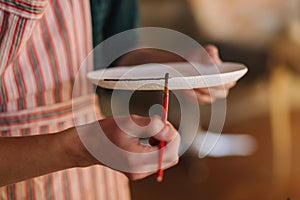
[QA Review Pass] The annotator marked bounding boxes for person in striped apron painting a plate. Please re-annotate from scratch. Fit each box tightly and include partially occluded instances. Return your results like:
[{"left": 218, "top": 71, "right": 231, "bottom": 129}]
[{"left": 0, "top": 0, "right": 232, "bottom": 200}]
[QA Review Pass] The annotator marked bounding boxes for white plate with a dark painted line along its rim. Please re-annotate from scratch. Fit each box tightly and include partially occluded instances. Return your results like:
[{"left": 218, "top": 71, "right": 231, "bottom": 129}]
[{"left": 87, "top": 62, "right": 248, "bottom": 90}]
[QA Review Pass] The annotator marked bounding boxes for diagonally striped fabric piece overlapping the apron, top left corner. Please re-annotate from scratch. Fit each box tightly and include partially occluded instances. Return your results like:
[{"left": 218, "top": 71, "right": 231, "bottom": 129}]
[{"left": 0, "top": 0, "right": 48, "bottom": 75}]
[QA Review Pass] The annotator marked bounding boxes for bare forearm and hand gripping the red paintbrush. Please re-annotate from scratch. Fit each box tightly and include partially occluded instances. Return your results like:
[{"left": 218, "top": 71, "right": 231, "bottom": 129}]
[{"left": 0, "top": 116, "right": 179, "bottom": 186}]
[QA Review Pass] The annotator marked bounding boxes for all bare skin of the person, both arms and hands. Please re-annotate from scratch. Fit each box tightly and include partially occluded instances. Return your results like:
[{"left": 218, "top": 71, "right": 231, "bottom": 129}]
[{"left": 0, "top": 46, "right": 235, "bottom": 186}]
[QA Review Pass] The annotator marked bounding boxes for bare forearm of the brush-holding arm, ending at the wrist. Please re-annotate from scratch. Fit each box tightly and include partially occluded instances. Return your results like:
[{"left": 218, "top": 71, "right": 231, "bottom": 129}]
[{"left": 0, "top": 128, "right": 91, "bottom": 186}]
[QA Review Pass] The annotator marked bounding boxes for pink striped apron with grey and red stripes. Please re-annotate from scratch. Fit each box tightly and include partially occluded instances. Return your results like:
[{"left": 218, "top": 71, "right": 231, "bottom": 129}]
[{"left": 0, "top": 0, "right": 130, "bottom": 200}]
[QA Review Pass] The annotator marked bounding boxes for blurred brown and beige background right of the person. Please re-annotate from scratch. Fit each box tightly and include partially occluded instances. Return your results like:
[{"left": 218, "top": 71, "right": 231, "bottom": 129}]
[{"left": 127, "top": 0, "right": 300, "bottom": 200}]
